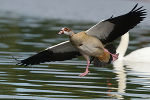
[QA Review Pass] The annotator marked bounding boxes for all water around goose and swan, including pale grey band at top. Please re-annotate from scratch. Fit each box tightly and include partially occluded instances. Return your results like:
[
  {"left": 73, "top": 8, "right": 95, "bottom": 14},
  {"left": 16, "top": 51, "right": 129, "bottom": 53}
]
[{"left": 0, "top": 0, "right": 150, "bottom": 100}]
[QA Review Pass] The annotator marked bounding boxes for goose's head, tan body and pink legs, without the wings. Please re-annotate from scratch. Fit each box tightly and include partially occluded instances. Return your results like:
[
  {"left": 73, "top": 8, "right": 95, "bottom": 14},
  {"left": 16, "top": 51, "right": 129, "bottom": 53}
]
[{"left": 58, "top": 28, "right": 118, "bottom": 76}]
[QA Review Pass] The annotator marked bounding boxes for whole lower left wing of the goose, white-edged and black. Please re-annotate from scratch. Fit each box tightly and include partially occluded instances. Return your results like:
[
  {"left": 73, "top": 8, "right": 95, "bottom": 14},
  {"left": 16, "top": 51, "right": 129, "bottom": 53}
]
[{"left": 18, "top": 41, "right": 80, "bottom": 66}]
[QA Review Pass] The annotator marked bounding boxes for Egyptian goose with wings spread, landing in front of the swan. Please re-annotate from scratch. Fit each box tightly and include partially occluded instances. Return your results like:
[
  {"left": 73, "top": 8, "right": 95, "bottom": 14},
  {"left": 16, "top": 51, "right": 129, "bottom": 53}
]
[{"left": 18, "top": 4, "right": 146, "bottom": 76}]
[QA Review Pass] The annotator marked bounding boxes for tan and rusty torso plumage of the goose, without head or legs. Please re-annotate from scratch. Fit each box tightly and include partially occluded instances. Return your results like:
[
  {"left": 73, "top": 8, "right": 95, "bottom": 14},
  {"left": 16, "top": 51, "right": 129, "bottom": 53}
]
[{"left": 70, "top": 31, "right": 110, "bottom": 62}]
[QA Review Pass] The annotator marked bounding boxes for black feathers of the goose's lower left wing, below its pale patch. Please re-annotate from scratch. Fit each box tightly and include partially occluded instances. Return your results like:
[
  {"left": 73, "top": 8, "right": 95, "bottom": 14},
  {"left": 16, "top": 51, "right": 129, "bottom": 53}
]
[{"left": 17, "top": 50, "right": 80, "bottom": 66}]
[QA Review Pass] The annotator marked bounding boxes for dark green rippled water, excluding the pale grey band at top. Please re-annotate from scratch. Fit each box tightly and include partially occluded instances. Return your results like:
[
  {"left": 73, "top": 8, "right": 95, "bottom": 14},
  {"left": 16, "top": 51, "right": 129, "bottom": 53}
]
[{"left": 0, "top": 17, "right": 150, "bottom": 100}]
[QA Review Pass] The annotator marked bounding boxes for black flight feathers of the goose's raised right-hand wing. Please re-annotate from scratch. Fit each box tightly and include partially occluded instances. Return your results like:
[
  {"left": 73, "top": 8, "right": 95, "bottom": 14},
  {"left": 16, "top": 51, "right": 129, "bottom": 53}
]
[{"left": 103, "top": 3, "right": 147, "bottom": 43}]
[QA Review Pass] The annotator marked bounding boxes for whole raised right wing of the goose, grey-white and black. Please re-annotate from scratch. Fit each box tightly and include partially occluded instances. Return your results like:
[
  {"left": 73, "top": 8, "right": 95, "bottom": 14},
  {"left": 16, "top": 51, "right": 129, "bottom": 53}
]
[{"left": 86, "top": 4, "right": 146, "bottom": 44}]
